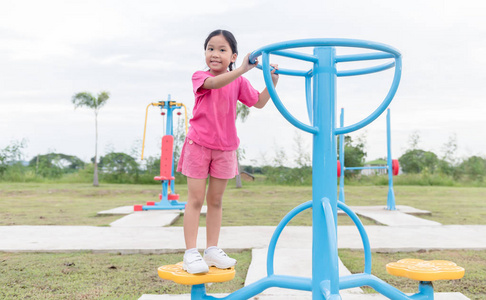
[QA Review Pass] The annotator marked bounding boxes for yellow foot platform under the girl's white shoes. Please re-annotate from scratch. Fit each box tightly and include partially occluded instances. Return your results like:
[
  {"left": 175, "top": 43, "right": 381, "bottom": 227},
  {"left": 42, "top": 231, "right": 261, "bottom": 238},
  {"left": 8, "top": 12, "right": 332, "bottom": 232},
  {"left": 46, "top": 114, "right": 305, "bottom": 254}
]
[{"left": 158, "top": 262, "right": 236, "bottom": 285}]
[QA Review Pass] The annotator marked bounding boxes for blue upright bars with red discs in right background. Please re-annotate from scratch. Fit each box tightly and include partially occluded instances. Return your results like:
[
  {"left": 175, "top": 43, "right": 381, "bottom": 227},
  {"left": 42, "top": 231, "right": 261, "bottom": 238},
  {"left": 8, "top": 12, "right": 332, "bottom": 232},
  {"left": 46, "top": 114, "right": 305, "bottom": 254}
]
[{"left": 338, "top": 108, "right": 400, "bottom": 210}]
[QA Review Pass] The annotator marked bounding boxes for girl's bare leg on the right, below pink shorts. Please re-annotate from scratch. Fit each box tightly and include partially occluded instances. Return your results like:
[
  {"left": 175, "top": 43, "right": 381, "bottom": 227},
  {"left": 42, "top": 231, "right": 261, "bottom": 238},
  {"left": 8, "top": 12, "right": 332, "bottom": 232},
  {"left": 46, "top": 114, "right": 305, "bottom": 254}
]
[{"left": 206, "top": 176, "right": 228, "bottom": 248}]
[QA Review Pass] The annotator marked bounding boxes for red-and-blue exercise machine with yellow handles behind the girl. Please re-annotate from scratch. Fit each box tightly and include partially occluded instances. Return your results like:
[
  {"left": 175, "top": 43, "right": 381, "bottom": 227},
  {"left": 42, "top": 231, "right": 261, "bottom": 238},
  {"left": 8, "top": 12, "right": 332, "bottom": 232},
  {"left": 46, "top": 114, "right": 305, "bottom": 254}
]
[{"left": 133, "top": 94, "right": 187, "bottom": 211}]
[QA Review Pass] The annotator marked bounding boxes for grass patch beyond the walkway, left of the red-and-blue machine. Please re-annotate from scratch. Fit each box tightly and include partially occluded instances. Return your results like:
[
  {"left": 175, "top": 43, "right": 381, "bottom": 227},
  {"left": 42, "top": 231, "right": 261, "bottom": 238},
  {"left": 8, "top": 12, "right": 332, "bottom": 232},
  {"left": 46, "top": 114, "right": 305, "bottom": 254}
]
[{"left": 0, "top": 183, "right": 160, "bottom": 226}]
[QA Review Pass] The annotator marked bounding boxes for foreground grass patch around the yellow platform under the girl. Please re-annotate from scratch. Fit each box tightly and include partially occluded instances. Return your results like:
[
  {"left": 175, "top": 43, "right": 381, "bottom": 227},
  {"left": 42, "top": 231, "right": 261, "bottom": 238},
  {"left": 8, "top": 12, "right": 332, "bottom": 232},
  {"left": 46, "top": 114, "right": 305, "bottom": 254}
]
[{"left": 0, "top": 251, "right": 251, "bottom": 299}]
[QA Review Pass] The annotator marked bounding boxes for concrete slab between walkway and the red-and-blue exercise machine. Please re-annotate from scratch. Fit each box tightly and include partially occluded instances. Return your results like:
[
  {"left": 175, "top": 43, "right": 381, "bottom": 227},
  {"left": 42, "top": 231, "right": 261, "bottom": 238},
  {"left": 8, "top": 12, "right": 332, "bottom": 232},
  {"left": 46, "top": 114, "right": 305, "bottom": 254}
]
[{"left": 110, "top": 210, "right": 180, "bottom": 227}]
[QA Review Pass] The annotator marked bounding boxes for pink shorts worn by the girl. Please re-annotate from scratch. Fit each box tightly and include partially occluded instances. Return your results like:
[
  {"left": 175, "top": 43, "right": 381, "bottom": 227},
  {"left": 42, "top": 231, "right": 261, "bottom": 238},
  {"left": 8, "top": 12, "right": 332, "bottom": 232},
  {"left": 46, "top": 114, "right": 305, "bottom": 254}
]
[{"left": 177, "top": 138, "right": 238, "bottom": 179}]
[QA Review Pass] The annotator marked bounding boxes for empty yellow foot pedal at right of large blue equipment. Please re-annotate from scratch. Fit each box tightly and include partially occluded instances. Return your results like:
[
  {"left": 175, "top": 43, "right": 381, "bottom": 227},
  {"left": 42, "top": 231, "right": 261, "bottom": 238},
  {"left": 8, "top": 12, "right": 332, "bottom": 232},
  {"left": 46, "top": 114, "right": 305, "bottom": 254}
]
[{"left": 386, "top": 258, "right": 465, "bottom": 281}]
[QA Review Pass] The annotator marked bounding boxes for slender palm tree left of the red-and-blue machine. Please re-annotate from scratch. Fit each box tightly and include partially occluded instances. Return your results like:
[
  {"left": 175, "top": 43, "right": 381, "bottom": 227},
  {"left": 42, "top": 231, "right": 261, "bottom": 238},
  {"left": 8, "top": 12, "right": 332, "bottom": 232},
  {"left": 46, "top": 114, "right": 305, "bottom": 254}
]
[{"left": 72, "top": 91, "right": 110, "bottom": 186}]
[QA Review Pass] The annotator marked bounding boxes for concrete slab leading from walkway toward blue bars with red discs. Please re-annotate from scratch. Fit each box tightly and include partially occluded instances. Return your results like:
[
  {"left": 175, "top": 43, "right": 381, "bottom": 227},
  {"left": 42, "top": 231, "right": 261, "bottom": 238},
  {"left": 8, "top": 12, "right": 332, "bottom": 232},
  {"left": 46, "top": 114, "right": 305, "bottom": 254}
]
[{"left": 351, "top": 206, "right": 442, "bottom": 226}]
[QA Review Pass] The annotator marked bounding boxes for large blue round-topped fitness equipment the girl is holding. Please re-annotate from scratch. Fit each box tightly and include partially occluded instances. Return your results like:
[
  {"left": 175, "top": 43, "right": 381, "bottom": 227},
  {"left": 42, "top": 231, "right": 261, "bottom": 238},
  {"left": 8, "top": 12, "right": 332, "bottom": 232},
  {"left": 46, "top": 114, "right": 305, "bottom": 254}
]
[{"left": 159, "top": 39, "right": 464, "bottom": 300}]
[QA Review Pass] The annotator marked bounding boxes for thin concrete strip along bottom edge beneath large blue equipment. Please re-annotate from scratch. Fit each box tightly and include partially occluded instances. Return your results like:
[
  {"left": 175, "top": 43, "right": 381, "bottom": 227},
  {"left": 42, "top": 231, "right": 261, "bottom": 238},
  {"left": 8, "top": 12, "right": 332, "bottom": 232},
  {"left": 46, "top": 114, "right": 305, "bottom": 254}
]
[{"left": 138, "top": 293, "right": 469, "bottom": 300}]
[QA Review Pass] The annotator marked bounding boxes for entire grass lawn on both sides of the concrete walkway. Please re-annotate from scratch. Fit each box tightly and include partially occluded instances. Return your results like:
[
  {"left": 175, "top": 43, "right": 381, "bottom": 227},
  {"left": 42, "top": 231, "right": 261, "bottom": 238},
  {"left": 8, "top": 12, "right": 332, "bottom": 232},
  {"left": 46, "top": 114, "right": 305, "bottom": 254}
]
[{"left": 0, "top": 182, "right": 486, "bottom": 299}]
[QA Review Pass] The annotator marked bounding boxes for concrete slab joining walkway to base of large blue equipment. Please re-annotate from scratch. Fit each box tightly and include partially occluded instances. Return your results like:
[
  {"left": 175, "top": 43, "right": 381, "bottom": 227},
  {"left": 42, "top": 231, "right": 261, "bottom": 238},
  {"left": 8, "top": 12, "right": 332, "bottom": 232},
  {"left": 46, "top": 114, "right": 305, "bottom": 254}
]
[{"left": 245, "top": 248, "right": 363, "bottom": 297}]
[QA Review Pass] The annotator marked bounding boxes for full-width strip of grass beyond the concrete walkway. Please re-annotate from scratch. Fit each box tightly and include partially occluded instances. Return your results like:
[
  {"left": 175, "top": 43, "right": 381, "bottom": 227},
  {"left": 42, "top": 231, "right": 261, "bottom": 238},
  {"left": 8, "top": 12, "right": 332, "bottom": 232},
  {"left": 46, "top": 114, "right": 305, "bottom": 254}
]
[{"left": 0, "top": 182, "right": 486, "bottom": 226}]
